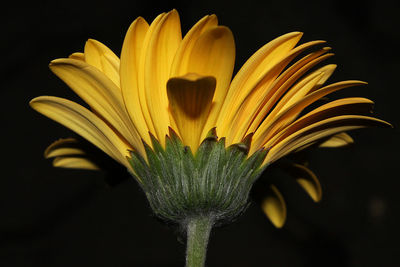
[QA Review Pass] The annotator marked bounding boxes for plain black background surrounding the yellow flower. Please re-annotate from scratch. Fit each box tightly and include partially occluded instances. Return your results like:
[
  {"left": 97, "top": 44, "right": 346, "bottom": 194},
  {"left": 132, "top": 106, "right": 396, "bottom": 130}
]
[{"left": 0, "top": 0, "right": 400, "bottom": 267}]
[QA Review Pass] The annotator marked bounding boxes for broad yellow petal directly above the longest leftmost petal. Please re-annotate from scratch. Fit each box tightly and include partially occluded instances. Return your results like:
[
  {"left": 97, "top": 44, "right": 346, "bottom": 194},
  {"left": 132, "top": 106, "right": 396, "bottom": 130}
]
[{"left": 50, "top": 59, "right": 144, "bottom": 155}]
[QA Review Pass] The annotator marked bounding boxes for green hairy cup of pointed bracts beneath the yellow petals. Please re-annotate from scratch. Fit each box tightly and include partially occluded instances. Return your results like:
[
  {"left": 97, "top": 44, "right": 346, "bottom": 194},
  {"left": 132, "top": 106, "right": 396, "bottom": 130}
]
[{"left": 129, "top": 128, "right": 267, "bottom": 224}]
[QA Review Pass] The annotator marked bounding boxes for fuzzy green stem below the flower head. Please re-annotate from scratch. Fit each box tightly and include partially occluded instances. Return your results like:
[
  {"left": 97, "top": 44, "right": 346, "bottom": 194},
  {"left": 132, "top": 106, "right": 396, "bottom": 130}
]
[{"left": 186, "top": 217, "right": 213, "bottom": 267}]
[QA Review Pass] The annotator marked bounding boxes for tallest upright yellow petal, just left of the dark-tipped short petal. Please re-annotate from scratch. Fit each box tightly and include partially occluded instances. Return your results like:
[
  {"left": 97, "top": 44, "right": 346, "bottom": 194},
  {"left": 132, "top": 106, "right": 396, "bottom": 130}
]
[{"left": 144, "top": 10, "right": 182, "bottom": 145}]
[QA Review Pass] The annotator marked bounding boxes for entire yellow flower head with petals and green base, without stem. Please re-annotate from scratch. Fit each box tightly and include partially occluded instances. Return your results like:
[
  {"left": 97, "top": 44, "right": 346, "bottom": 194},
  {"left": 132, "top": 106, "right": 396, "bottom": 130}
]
[{"left": 30, "top": 10, "right": 389, "bottom": 226}]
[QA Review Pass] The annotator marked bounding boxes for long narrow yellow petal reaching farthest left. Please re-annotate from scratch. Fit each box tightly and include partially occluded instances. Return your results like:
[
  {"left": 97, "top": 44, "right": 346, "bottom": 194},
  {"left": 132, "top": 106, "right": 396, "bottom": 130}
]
[{"left": 30, "top": 96, "right": 132, "bottom": 167}]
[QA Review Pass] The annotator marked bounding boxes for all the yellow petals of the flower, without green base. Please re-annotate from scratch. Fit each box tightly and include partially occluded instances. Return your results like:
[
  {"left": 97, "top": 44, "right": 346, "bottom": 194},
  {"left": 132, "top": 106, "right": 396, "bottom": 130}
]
[{"left": 30, "top": 10, "right": 389, "bottom": 229}]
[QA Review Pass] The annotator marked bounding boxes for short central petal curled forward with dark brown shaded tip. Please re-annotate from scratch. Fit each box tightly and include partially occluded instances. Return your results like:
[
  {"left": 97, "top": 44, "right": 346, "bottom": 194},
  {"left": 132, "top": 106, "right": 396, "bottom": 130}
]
[{"left": 167, "top": 73, "right": 216, "bottom": 153}]
